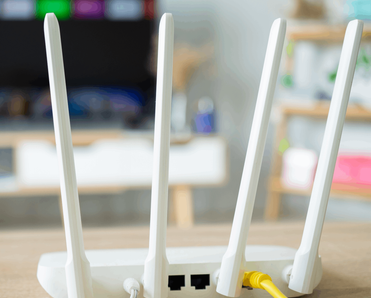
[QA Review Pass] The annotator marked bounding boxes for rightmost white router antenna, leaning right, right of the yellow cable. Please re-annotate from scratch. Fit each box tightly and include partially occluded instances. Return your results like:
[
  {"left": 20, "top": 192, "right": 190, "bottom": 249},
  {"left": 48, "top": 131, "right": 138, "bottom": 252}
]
[{"left": 289, "top": 20, "right": 363, "bottom": 294}]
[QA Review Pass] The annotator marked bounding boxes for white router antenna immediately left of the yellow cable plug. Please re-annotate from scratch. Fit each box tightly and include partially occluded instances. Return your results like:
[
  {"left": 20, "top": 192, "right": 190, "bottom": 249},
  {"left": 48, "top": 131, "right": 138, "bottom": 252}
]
[{"left": 217, "top": 19, "right": 286, "bottom": 297}]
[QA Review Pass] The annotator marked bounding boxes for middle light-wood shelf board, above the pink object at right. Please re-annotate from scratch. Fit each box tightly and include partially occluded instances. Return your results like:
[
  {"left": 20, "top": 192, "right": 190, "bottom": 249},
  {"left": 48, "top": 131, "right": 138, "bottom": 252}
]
[{"left": 279, "top": 102, "right": 371, "bottom": 121}]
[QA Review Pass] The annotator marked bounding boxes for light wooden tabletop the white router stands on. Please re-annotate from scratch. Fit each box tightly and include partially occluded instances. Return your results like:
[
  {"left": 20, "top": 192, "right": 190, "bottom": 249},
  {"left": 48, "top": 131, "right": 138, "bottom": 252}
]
[{"left": 0, "top": 223, "right": 371, "bottom": 298}]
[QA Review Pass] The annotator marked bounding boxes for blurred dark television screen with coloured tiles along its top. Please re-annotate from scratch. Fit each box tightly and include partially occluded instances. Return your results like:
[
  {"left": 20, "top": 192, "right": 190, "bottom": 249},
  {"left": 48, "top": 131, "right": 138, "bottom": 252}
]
[{"left": 0, "top": 0, "right": 155, "bottom": 125}]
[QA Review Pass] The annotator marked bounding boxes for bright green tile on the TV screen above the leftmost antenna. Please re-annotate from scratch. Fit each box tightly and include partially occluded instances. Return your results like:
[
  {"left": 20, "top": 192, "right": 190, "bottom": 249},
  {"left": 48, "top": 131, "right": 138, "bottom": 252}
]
[{"left": 36, "top": 0, "right": 71, "bottom": 20}]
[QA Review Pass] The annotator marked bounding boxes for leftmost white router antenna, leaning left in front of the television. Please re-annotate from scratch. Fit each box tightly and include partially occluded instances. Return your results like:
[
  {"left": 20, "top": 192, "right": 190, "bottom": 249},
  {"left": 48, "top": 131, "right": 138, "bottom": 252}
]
[{"left": 44, "top": 13, "right": 93, "bottom": 298}]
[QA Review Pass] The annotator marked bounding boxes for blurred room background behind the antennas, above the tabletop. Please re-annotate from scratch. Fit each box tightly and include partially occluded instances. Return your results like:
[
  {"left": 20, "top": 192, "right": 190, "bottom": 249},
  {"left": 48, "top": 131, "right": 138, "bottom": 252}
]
[{"left": 0, "top": 0, "right": 371, "bottom": 229}]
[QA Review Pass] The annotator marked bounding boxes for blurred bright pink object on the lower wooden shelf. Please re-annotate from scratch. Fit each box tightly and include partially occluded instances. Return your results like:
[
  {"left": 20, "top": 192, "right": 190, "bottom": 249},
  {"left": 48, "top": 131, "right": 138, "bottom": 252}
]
[{"left": 332, "top": 155, "right": 371, "bottom": 186}]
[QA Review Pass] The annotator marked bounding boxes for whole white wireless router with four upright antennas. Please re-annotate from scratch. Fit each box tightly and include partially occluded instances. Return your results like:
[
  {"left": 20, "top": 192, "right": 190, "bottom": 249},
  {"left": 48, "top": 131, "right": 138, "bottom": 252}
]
[{"left": 37, "top": 14, "right": 363, "bottom": 298}]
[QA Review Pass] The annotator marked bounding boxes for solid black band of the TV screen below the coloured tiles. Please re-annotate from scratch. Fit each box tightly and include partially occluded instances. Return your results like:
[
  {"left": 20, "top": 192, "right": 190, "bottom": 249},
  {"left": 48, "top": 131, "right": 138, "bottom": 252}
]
[{"left": 0, "top": 20, "right": 152, "bottom": 87}]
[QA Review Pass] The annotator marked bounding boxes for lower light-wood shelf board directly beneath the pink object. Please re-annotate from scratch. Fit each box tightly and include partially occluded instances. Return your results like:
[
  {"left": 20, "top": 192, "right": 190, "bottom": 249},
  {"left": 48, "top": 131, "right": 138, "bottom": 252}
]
[{"left": 270, "top": 177, "right": 371, "bottom": 200}]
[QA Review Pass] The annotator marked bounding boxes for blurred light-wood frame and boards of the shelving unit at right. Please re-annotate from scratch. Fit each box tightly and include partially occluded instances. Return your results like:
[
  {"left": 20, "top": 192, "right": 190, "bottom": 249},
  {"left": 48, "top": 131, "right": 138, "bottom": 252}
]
[{"left": 265, "top": 22, "right": 371, "bottom": 220}]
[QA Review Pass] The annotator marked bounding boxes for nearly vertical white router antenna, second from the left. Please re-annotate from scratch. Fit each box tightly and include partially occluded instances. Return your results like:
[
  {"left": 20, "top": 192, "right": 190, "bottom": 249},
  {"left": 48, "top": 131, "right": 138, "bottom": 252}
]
[{"left": 143, "top": 13, "right": 174, "bottom": 298}]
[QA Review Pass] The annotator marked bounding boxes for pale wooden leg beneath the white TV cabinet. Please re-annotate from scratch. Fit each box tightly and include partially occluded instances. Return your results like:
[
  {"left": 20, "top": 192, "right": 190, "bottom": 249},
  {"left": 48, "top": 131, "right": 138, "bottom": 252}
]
[{"left": 170, "top": 185, "right": 194, "bottom": 229}]
